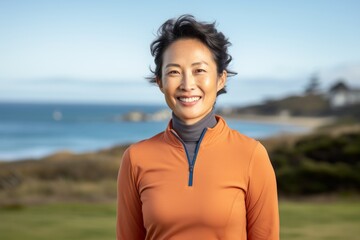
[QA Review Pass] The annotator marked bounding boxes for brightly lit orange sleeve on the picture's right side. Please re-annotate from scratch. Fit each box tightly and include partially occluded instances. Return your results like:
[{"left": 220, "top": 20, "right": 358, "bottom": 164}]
[{"left": 245, "top": 142, "right": 280, "bottom": 240}]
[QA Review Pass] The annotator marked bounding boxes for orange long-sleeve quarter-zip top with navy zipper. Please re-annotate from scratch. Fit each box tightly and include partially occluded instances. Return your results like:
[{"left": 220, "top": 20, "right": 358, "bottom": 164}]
[{"left": 117, "top": 116, "right": 279, "bottom": 240}]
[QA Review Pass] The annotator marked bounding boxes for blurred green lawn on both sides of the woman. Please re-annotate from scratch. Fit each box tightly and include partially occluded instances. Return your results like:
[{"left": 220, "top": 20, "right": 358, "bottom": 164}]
[{"left": 0, "top": 201, "right": 360, "bottom": 240}]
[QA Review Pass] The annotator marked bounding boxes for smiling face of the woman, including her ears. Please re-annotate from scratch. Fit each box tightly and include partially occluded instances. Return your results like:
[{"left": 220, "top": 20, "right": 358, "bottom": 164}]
[{"left": 157, "top": 39, "right": 227, "bottom": 125}]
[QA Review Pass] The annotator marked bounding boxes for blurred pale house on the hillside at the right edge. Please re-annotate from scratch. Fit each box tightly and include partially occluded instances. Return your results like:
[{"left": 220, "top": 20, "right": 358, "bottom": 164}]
[{"left": 328, "top": 81, "right": 360, "bottom": 108}]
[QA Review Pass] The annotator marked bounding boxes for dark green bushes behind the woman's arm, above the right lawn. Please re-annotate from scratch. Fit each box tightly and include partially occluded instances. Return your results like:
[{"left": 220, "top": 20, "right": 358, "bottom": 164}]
[{"left": 269, "top": 133, "right": 360, "bottom": 195}]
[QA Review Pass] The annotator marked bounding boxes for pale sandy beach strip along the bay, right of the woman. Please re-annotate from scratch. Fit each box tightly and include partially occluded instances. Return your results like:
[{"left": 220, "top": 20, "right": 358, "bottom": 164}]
[{"left": 225, "top": 114, "right": 334, "bottom": 130}]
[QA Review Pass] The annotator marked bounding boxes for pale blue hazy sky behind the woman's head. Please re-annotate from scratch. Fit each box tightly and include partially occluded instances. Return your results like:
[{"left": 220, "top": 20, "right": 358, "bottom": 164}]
[{"left": 0, "top": 0, "right": 360, "bottom": 105}]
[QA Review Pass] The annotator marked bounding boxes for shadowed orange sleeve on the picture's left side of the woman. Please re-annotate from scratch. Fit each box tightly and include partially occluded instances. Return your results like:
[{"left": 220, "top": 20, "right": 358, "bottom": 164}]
[{"left": 116, "top": 149, "right": 146, "bottom": 240}]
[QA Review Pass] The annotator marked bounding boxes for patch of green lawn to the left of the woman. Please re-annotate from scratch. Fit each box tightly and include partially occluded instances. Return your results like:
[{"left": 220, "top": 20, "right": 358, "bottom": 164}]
[{"left": 0, "top": 203, "right": 116, "bottom": 240}]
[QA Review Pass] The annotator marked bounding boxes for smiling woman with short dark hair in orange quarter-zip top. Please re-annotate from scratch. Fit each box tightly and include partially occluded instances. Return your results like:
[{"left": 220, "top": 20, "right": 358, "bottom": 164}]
[{"left": 117, "top": 15, "right": 279, "bottom": 240}]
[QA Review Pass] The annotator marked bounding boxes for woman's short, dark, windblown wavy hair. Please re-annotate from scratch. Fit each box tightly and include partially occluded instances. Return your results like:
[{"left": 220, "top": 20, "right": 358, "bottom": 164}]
[{"left": 147, "top": 14, "right": 237, "bottom": 95}]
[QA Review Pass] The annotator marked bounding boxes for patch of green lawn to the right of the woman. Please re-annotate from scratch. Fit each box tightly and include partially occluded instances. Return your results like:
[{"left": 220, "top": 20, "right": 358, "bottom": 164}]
[{"left": 280, "top": 201, "right": 360, "bottom": 240}]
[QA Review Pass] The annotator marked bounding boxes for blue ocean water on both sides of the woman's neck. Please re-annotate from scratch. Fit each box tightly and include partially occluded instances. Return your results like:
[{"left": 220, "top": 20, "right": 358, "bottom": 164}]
[{"left": 0, "top": 103, "right": 305, "bottom": 161}]
